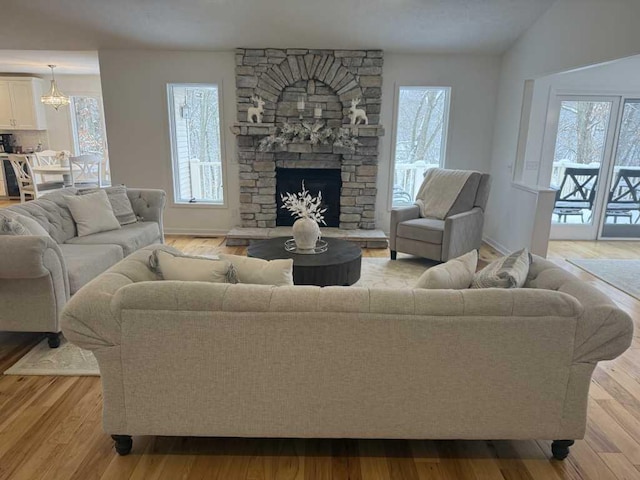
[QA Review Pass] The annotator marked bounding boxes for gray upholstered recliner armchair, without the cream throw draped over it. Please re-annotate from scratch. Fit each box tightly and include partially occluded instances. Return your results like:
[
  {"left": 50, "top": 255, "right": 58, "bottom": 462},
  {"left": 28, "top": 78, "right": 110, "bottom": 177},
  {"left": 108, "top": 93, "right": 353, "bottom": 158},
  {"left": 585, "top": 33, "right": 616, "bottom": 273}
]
[{"left": 389, "top": 172, "right": 491, "bottom": 262}]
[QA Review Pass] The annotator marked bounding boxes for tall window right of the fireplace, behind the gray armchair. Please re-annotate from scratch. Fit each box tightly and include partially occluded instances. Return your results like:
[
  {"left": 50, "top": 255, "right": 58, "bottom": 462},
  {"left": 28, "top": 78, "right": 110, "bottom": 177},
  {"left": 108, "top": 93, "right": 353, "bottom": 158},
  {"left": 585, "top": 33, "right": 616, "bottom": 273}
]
[{"left": 392, "top": 86, "right": 451, "bottom": 206}]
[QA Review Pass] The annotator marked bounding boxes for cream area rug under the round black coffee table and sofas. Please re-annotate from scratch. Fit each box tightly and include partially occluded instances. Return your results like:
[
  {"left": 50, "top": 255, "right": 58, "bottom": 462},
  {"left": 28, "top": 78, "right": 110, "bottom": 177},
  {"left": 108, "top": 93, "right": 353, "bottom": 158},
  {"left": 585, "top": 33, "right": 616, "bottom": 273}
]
[{"left": 4, "top": 257, "right": 435, "bottom": 376}]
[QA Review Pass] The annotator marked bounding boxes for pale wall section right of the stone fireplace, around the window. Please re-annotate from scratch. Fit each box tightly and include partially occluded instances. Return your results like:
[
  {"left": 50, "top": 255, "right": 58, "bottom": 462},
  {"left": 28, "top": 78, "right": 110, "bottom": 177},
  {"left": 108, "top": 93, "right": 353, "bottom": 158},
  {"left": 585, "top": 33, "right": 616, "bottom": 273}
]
[{"left": 376, "top": 53, "right": 500, "bottom": 232}]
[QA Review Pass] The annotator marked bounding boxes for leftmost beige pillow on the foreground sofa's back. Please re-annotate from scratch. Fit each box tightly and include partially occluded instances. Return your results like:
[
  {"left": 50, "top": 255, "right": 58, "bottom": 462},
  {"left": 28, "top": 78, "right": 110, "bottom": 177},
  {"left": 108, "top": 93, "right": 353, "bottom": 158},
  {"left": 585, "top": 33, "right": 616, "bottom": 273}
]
[{"left": 149, "top": 249, "right": 238, "bottom": 283}]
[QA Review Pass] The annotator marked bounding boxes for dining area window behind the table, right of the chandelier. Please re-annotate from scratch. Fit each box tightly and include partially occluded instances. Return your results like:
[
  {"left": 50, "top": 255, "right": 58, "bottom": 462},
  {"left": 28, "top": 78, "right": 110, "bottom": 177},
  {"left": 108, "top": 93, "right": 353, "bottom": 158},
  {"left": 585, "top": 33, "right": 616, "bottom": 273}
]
[{"left": 70, "top": 94, "right": 110, "bottom": 185}]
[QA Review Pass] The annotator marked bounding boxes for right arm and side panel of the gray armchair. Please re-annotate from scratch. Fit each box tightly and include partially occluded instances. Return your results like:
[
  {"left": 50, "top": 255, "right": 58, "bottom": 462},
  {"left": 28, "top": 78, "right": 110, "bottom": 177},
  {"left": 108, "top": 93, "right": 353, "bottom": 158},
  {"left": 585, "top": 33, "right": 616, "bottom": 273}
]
[{"left": 442, "top": 207, "right": 484, "bottom": 262}]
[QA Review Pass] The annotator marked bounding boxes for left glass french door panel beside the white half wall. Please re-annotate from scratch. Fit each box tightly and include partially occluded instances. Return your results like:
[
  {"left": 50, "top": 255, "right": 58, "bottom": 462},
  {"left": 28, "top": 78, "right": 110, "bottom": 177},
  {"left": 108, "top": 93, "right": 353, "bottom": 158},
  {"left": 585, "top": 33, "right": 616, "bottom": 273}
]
[{"left": 549, "top": 95, "right": 620, "bottom": 240}]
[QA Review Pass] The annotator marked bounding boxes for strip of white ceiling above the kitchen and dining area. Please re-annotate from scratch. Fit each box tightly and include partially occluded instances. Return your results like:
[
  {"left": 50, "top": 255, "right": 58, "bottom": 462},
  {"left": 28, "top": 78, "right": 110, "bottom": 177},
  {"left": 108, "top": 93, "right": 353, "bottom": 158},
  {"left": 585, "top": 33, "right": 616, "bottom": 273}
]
[{"left": 0, "top": 50, "right": 100, "bottom": 75}]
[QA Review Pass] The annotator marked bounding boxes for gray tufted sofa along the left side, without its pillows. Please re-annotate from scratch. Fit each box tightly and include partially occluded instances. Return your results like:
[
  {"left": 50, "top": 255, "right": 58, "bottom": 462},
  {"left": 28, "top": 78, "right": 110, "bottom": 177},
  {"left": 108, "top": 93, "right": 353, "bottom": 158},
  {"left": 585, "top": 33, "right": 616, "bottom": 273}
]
[{"left": 0, "top": 188, "right": 166, "bottom": 347}]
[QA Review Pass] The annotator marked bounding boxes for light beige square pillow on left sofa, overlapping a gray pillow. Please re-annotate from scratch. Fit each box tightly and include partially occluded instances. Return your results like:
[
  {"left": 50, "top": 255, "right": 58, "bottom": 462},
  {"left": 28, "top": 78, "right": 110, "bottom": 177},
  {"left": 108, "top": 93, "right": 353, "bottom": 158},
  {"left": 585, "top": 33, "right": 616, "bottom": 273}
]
[{"left": 67, "top": 190, "right": 120, "bottom": 237}]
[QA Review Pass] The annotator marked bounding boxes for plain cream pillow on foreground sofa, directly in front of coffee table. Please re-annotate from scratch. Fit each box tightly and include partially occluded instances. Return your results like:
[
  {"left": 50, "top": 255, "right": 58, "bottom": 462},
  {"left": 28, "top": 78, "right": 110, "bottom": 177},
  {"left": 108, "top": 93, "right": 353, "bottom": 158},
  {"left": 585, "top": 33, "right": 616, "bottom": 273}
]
[{"left": 220, "top": 254, "right": 293, "bottom": 286}]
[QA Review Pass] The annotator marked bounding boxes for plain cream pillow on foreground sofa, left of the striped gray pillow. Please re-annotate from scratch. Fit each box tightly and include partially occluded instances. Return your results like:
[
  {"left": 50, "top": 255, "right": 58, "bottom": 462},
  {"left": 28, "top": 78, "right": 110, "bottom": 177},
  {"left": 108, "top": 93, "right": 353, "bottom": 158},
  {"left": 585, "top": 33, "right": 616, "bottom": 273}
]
[{"left": 414, "top": 250, "right": 478, "bottom": 290}]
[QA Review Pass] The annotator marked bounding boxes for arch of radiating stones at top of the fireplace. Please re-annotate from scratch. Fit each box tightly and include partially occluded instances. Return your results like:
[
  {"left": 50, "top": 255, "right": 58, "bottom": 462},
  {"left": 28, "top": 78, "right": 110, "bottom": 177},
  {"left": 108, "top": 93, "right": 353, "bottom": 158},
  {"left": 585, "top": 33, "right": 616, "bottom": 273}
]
[{"left": 255, "top": 53, "right": 363, "bottom": 108}]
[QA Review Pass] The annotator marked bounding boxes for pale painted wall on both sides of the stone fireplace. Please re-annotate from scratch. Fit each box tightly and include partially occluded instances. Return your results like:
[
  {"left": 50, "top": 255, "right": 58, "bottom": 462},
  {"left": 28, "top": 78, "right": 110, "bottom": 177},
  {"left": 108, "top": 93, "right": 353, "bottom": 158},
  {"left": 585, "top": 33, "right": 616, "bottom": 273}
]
[{"left": 99, "top": 50, "right": 500, "bottom": 234}]
